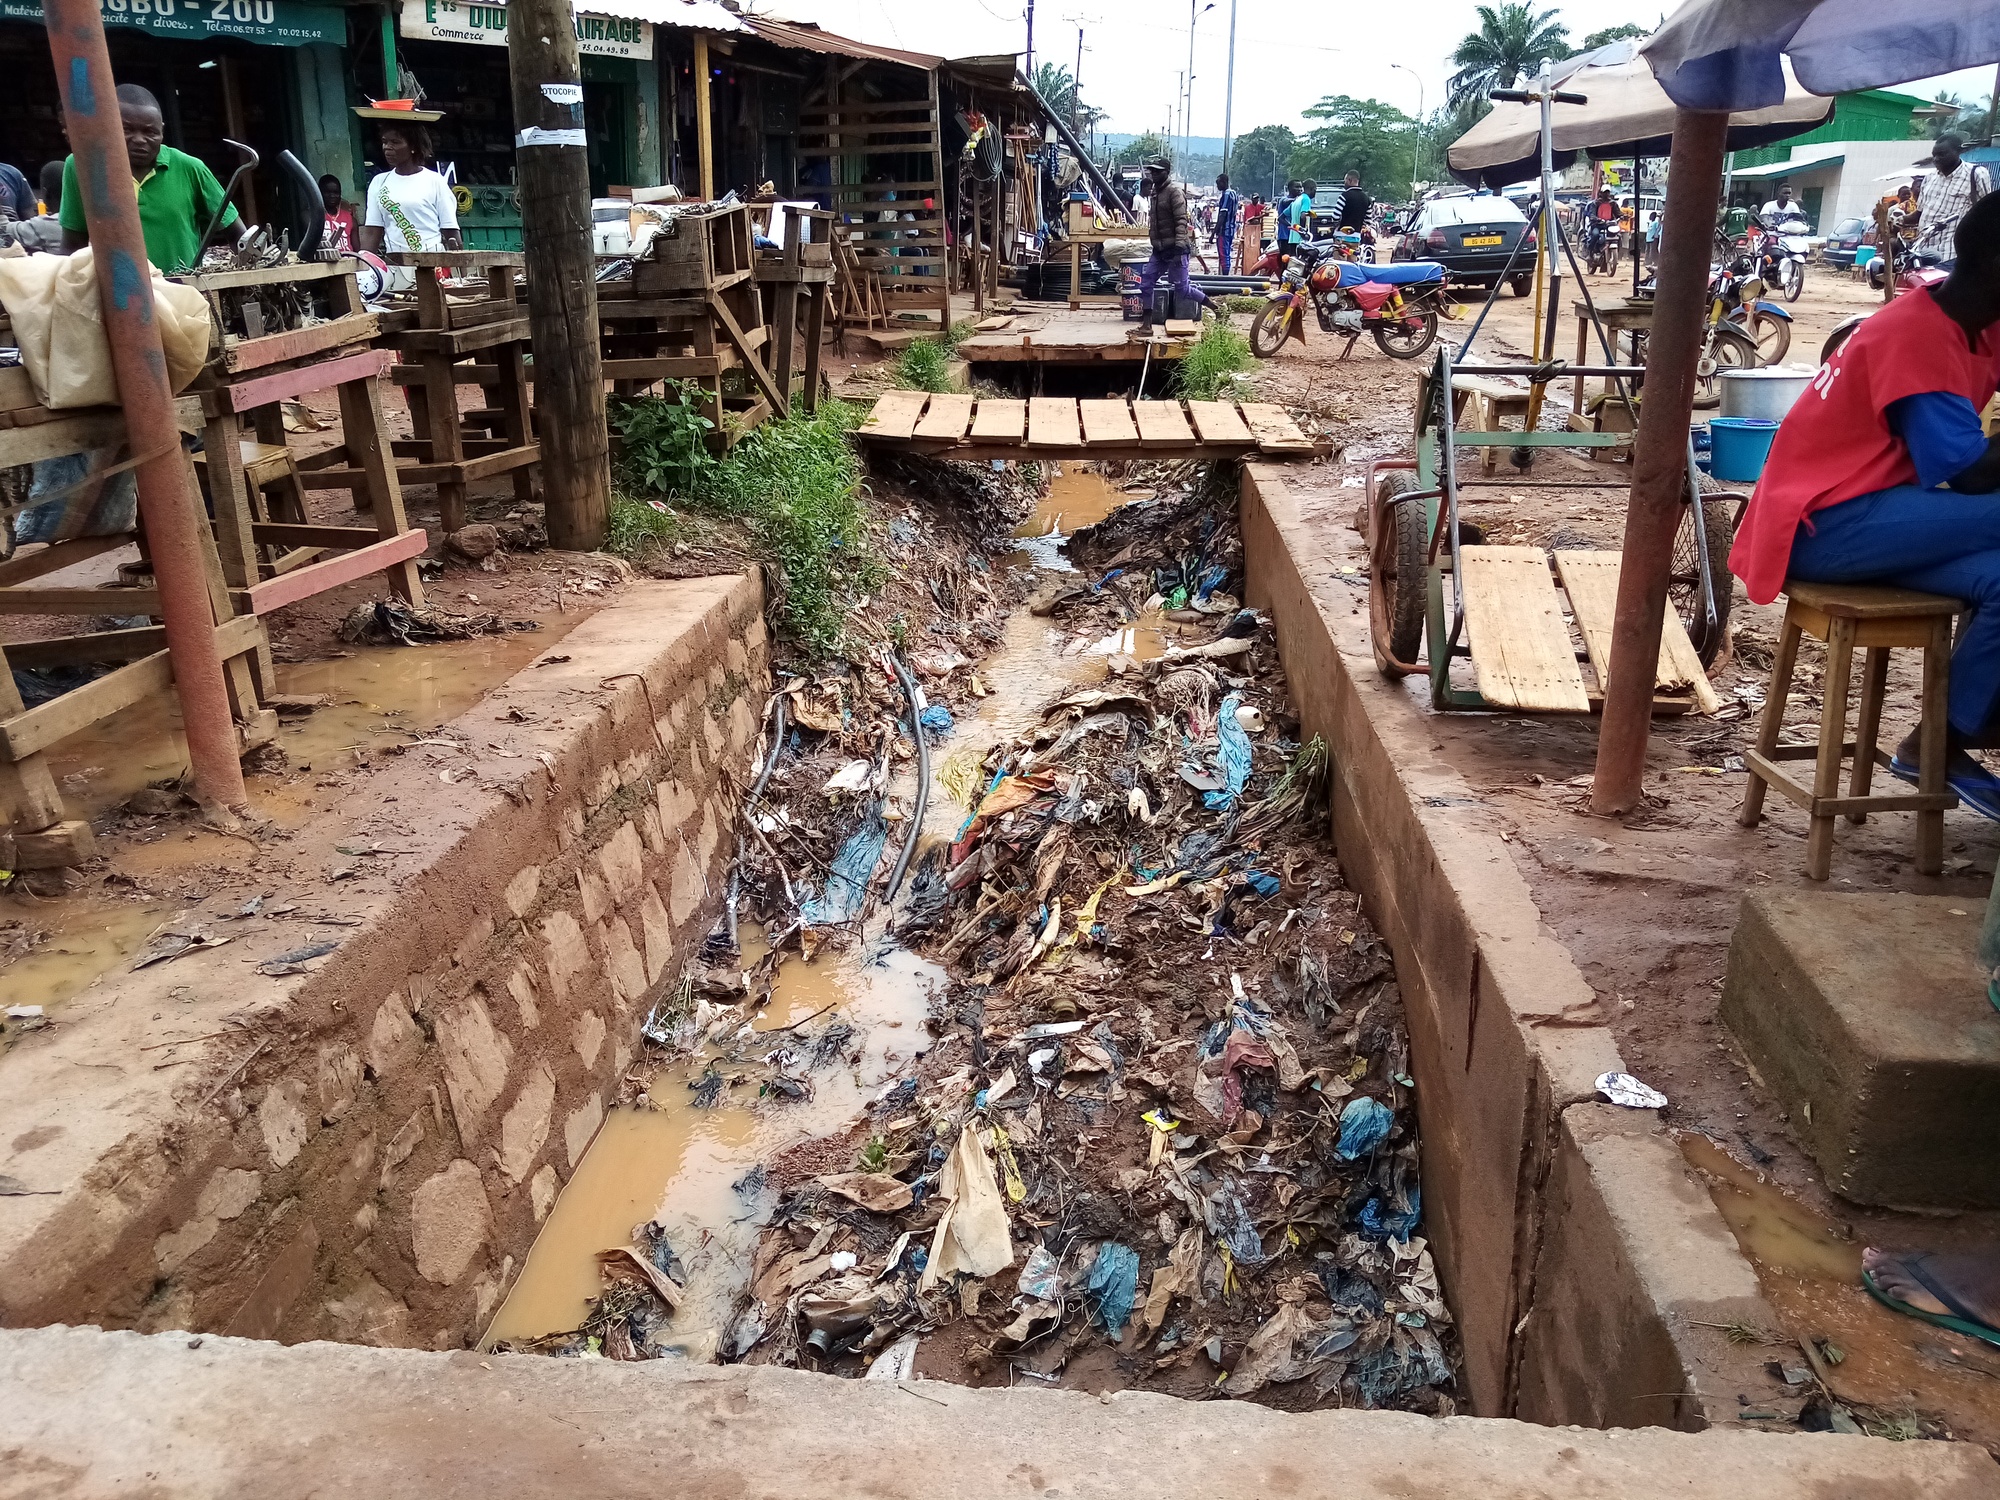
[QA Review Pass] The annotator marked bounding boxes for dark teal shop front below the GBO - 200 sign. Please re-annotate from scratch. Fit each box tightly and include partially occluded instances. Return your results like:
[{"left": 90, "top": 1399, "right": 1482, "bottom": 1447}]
[{"left": 0, "top": 0, "right": 354, "bottom": 226}]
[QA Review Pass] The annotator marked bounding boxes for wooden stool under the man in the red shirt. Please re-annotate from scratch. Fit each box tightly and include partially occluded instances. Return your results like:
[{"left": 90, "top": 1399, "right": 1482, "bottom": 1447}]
[{"left": 1738, "top": 580, "right": 1964, "bottom": 880}]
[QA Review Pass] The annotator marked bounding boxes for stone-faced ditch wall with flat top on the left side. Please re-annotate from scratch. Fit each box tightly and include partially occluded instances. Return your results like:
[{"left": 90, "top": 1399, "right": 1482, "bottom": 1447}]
[{"left": 0, "top": 578, "right": 770, "bottom": 1348}]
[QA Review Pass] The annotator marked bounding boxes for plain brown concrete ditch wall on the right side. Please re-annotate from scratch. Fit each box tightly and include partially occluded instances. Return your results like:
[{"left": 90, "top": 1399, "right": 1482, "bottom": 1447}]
[{"left": 1242, "top": 464, "right": 1778, "bottom": 1428}]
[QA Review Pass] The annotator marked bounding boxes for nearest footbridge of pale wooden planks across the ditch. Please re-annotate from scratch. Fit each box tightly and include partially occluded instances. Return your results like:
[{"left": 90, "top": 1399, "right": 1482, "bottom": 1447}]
[{"left": 856, "top": 390, "right": 1332, "bottom": 462}]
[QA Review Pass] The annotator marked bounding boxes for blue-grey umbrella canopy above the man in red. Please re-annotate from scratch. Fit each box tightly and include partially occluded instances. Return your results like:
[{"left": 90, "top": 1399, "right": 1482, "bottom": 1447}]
[{"left": 1640, "top": 0, "right": 2000, "bottom": 110}]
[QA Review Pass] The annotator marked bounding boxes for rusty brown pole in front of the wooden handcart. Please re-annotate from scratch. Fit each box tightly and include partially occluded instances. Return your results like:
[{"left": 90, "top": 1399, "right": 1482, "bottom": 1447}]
[{"left": 1590, "top": 110, "right": 1730, "bottom": 816}]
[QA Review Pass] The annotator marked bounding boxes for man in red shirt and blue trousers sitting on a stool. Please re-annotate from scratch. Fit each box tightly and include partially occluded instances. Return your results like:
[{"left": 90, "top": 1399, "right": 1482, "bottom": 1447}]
[{"left": 1730, "top": 192, "right": 2000, "bottom": 820}]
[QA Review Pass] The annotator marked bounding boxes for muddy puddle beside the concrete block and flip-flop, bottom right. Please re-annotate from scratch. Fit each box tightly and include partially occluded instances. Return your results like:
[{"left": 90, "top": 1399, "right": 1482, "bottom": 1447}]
[{"left": 1680, "top": 1134, "right": 2000, "bottom": 1444}]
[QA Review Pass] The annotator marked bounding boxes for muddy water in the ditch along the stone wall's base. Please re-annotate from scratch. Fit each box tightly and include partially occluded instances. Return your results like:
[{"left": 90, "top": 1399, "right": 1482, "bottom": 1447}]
[{"left": 480, "top": 928, "right": 944, "bottom": 1358}]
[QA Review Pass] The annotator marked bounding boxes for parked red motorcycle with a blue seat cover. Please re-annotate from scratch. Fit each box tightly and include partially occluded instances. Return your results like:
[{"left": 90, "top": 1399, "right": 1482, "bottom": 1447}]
[{"left": 1250, "top": 242, "right": 1444, "bottom": 360}]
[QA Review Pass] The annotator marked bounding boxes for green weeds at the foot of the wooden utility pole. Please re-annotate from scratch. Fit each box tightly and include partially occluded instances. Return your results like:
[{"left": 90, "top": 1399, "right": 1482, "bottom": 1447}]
[{"left": 608, "top": 392, "right": 876, "bottom": 654}]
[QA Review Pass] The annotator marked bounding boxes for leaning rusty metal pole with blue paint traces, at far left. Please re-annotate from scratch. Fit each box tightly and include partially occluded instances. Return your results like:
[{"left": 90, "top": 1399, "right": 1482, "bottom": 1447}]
[{"left": 44, "top": 0, "right": 248, "bottom": 824}]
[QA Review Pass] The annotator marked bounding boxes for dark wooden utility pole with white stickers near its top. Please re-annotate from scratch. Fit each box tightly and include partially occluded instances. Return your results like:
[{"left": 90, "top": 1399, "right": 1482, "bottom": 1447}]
[{"left": 506, "top": 0, "right": 612, "bottom": 552}]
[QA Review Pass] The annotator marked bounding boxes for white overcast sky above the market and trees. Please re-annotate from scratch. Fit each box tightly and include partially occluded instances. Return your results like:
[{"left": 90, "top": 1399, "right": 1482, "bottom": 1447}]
[{"left": 752, "top": 0, "right": 1992, "bottom": 136}]
